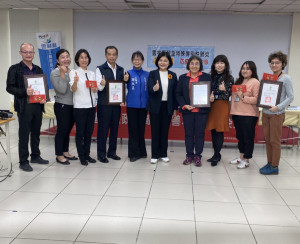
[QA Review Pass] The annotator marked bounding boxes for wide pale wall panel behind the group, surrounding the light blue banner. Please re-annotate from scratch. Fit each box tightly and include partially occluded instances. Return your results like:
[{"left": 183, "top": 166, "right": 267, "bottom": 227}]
[{"left": 74, "top": 12, "right": 292, "bottom": 77}]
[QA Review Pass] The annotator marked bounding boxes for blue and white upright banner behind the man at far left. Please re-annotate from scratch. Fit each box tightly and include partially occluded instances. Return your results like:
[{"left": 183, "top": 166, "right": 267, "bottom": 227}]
[{"left": 36, "top": 32, "right": 62, "bottom": 89}]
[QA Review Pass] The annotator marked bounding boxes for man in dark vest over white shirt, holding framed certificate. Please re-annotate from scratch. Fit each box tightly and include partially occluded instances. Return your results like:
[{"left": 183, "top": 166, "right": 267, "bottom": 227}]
[{"left": 96, "top": 46, "right": 124, "bottom": 163}]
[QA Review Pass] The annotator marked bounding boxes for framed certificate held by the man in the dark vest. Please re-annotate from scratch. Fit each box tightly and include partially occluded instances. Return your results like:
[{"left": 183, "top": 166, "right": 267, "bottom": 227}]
[{"left": 106, "top": 80, "right": 125, "bottom": 105}]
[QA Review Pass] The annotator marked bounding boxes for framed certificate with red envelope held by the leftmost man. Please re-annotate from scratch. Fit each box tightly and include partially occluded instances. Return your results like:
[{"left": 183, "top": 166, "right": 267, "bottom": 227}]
[{"left": 24, "top": 74, "right": 50, "bottom": 103}]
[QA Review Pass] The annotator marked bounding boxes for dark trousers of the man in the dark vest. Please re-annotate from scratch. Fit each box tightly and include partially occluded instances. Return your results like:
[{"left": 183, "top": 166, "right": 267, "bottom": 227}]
[{"left": 97, "top": 105, "right": 121, "bottom": 158}]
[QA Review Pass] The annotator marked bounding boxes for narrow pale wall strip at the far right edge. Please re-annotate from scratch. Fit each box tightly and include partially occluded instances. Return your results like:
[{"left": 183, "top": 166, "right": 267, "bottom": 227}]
[{"left": 288, "top": 13, "right": 300, "bottom": 106}]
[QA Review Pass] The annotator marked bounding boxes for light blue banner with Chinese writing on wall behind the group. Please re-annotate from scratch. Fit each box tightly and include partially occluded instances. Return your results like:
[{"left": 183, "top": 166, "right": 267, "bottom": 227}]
[{"left": 147, "top": 45, "right": 215, "bottom": 70}]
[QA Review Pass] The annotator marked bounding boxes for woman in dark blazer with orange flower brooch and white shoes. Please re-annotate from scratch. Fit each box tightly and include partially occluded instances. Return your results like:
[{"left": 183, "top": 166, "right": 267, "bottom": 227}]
[{"left": 147, "top": 51, "right": 178, "bottom": 164}]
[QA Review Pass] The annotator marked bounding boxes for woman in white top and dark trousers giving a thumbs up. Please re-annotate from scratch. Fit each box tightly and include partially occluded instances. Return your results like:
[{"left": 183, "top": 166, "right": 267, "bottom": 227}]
[{"left": 70, "top": 49, "right": 98, "bottom": 165}]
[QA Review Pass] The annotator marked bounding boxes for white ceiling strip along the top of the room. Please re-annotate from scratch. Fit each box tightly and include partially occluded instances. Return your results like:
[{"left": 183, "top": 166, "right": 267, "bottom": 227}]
[{"left": 0, "top": 0, "right": 300, "bottom": 13}]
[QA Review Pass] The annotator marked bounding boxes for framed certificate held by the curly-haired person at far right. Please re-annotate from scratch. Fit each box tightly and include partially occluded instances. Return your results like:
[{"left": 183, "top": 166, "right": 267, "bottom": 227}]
[{"left": 257, "top": 80, "right": 283, "bottom": 108}]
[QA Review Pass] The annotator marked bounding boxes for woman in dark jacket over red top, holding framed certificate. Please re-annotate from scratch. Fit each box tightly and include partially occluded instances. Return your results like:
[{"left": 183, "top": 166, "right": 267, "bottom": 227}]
[{"left": 176, "top": 55, "right": 211, "bottom": 167}]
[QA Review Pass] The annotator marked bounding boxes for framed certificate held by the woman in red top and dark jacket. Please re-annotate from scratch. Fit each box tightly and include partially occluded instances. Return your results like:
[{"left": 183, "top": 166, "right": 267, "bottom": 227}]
[{"left": 191, "top": 81, "right": 210, "bottom": 107}]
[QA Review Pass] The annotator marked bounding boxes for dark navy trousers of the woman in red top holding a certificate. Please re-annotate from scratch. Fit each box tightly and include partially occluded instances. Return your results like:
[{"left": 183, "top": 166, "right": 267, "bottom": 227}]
[{"left": 182, "top": 113, "right": 208, "bottom": 158}]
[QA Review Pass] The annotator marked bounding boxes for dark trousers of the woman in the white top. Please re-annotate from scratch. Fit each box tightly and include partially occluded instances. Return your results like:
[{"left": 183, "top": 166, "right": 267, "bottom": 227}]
[{"left": 73, "top": 108, "right": 96, "bottom": 160}]
